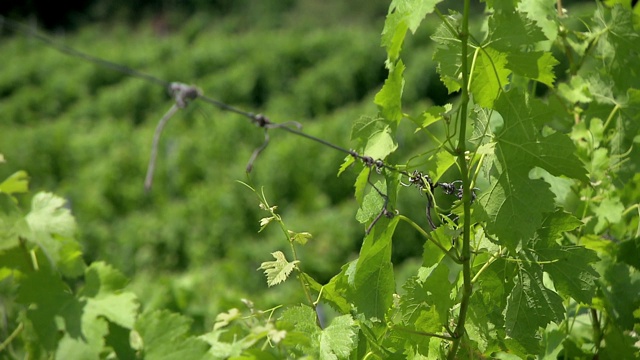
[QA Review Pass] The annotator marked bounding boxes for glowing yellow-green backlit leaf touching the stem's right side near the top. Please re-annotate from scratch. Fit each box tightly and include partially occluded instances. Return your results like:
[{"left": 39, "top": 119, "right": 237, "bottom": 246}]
[{"left": 470, "top": 47, "right": 511, "bottom": 108}]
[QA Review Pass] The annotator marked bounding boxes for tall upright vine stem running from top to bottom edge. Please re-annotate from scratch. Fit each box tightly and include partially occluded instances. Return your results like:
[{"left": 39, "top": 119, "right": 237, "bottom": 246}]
[{"left": 447, "top": 0, "right": 473, "bottom": 360}]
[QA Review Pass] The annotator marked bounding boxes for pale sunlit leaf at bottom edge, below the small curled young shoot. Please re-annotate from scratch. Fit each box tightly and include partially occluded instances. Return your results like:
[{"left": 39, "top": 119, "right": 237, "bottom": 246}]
[{"left": 320, "top": 315, "right": 357, "bottom": 360}]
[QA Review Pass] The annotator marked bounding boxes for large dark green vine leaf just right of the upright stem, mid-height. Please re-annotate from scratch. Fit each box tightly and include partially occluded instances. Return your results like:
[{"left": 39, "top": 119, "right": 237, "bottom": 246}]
[{"left": 478, "top": 90, "right": 587, "bottom": 250}]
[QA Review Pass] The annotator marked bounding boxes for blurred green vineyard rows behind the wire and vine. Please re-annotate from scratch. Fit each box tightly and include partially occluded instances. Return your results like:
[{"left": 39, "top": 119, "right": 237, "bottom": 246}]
[{"left": 0, "top": 0, "right": 596, "bottom": 334}]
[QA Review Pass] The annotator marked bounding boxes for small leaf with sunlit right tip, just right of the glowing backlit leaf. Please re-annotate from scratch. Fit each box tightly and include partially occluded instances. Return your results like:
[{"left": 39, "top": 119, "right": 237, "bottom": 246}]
[{"left": 506, "top": 51, "right": 559, "bottom": 87}]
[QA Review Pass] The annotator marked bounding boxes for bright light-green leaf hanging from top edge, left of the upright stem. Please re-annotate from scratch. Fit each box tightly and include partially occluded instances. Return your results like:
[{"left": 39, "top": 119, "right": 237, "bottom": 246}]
[{"left": 382, "top": 0, "right": 442, "bottom": 62}]
